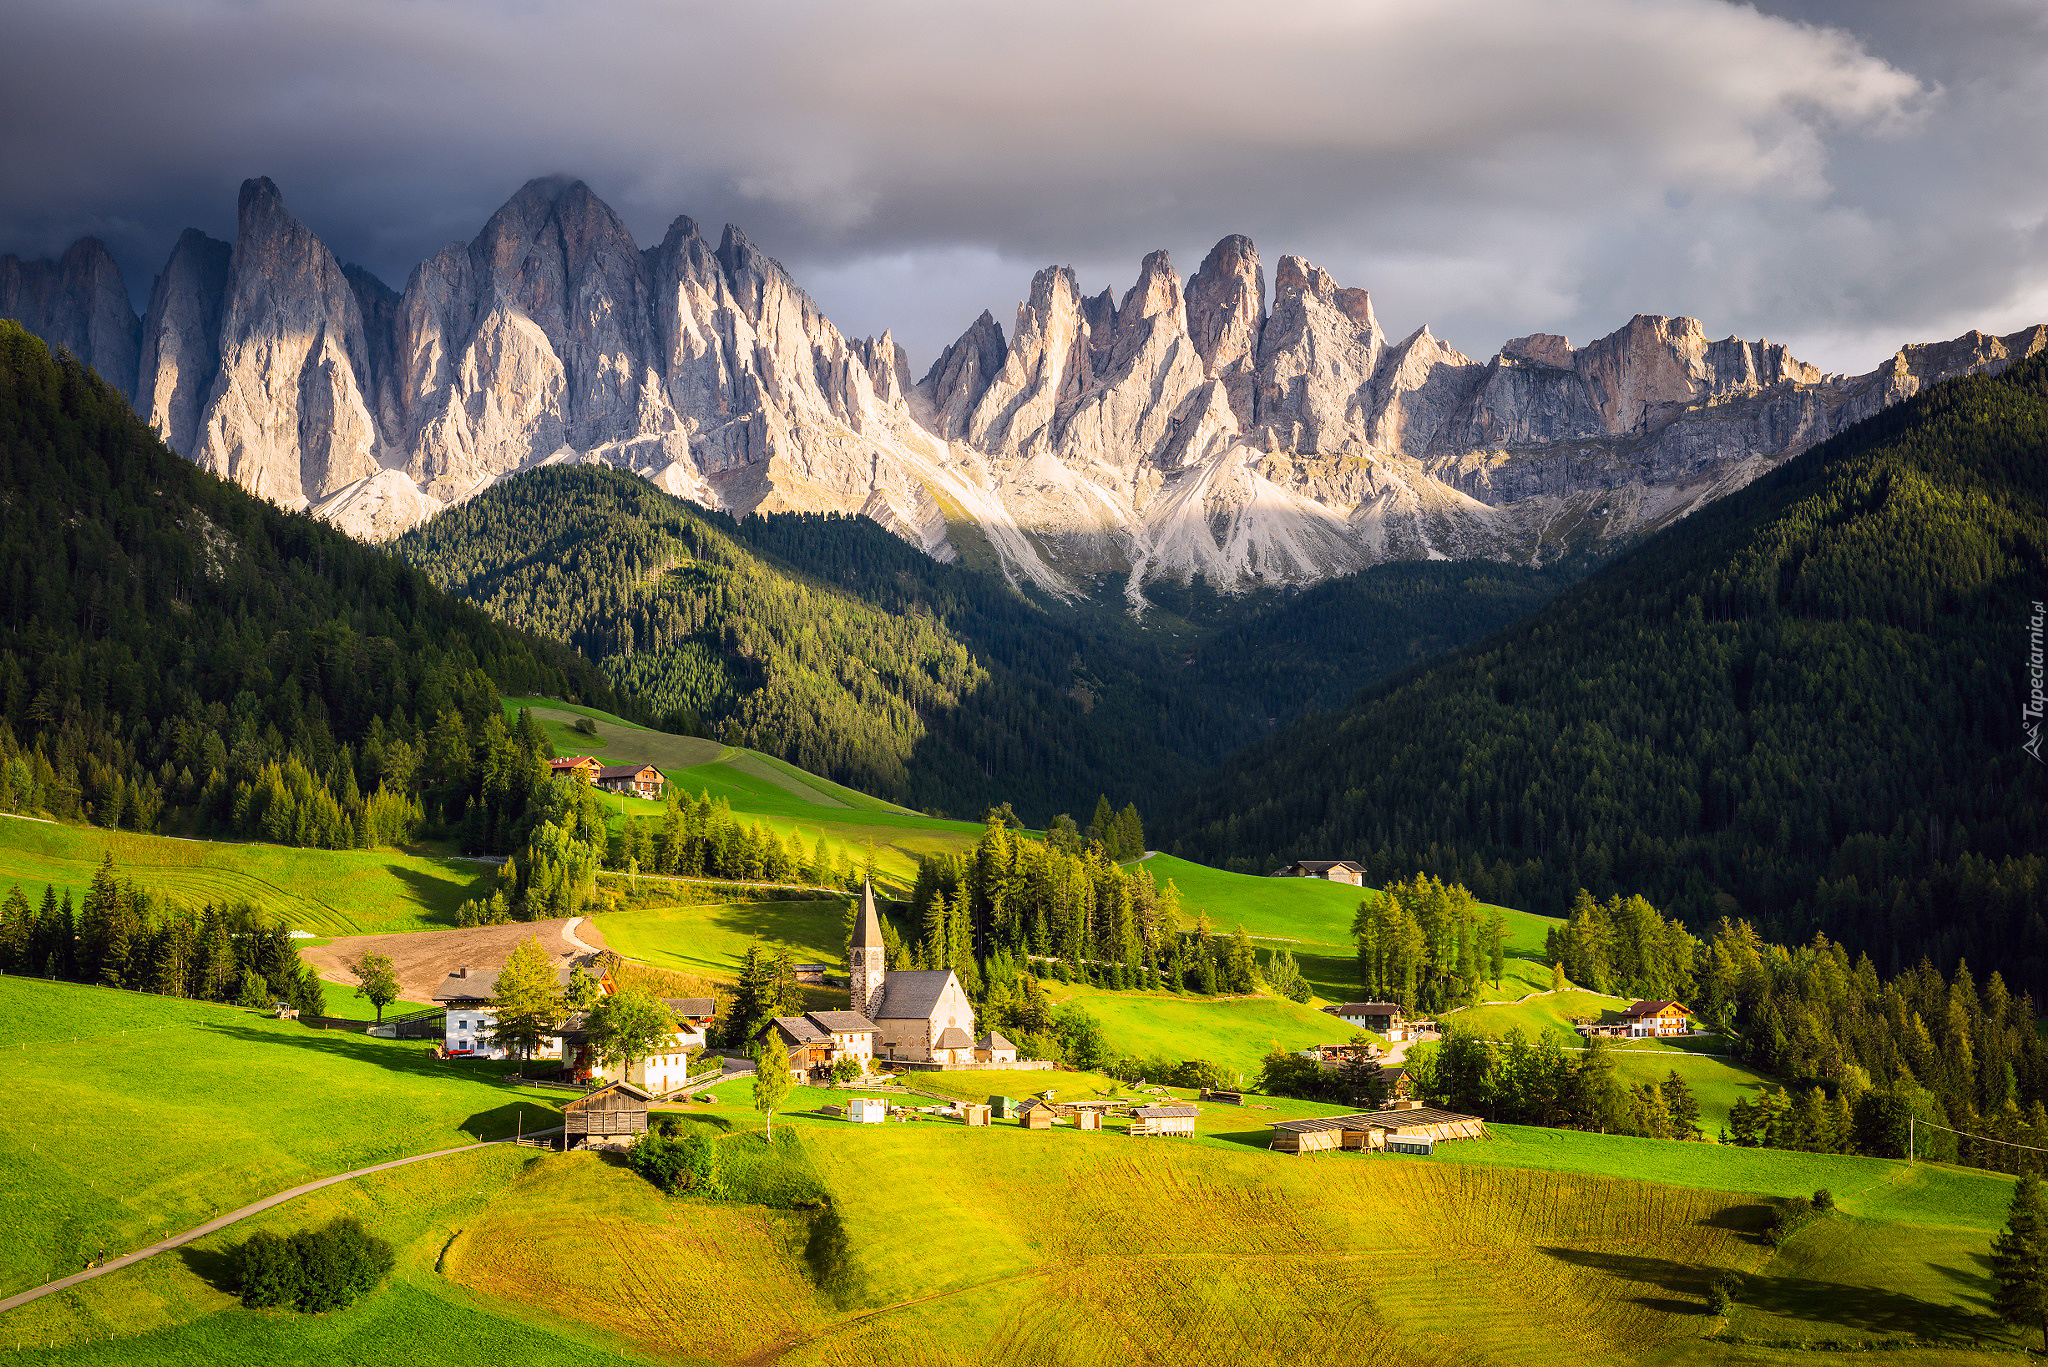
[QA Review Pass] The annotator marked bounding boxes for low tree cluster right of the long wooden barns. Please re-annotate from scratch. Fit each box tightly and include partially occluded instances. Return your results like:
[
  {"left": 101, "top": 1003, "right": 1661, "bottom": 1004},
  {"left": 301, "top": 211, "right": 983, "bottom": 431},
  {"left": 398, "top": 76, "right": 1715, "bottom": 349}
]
[{"left": 1407, "top": 1027, "right": 1700, "bottom": 1140}]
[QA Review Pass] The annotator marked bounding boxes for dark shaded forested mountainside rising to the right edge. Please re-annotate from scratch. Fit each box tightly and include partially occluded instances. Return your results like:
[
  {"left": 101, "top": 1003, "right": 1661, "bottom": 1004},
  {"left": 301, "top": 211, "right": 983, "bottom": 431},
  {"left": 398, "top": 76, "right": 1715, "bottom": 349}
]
[{"left": 1169, "top": 359, "right": 2048, "bottom": 994}]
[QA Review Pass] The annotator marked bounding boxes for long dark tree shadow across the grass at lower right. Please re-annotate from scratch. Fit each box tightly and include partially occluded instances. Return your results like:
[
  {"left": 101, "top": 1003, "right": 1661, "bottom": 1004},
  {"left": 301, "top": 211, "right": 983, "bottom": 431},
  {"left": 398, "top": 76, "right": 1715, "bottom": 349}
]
[{"left": 1542, "top": 1248, "right": 2003, "bottom": 1340}]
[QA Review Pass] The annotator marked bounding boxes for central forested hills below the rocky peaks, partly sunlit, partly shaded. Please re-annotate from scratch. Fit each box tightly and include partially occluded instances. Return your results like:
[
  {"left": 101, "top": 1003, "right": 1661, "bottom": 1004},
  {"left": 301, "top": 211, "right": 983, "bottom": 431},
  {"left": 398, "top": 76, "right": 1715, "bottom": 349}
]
[{"left": 393, "top": 465, "right": 1552, "bottom": 820}]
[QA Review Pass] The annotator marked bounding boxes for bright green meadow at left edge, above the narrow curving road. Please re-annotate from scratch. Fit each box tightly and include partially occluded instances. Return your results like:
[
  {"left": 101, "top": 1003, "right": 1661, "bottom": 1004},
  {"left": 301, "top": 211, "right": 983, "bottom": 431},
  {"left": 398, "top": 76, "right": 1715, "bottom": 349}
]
[{"left": 0, "top": 978, "right": 577, "bottom": 1291}]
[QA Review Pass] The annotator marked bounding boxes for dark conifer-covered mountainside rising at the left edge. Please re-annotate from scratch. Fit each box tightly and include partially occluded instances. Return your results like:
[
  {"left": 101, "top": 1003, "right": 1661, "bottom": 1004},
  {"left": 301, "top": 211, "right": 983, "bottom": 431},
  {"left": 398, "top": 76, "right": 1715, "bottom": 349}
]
[{"left": 0, "top": 322, "right": 614, "bottom": 846}]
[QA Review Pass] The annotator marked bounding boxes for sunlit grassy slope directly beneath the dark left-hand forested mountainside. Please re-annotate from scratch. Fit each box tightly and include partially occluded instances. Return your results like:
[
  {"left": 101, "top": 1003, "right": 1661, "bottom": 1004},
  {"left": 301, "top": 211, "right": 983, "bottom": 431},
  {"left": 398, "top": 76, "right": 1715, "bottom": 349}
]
[{"left": 0, "top": 818, "right": 481, "bottom": 935}]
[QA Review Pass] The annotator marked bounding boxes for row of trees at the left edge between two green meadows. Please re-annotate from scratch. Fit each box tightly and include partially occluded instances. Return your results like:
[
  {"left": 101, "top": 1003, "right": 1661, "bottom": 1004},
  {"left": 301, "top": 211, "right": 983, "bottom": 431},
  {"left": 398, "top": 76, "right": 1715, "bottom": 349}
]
[{"left": 0, "top": 857, "right": 326, "bottom": 1017}]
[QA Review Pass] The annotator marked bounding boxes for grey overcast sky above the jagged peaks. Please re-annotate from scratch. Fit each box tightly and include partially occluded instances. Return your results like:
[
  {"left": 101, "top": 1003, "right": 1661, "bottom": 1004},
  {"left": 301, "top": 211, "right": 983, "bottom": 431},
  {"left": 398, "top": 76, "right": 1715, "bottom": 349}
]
[{"left": 0, "top": 0, "right": 2048, "bottom": 371}]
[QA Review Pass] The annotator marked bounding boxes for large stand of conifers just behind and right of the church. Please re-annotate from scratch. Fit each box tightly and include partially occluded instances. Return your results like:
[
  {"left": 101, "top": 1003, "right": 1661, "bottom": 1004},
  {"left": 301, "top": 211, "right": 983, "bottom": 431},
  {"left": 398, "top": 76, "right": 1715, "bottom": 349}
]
[{"left": 899, "top": 819, "right": 1260, "bottom": 994}]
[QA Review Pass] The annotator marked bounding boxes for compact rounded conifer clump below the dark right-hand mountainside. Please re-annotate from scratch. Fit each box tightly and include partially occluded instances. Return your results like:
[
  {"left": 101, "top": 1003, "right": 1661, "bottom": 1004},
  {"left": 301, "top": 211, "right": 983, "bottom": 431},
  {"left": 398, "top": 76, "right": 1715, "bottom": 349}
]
[{"left": 1352, "top": 873, "right": 1507, "bottom": 1012}]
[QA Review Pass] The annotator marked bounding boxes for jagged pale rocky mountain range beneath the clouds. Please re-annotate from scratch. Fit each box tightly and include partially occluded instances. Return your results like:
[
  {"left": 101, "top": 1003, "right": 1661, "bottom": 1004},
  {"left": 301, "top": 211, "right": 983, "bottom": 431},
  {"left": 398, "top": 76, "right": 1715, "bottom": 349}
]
[{"left": 0, "top": 178, "right": 2048, "bottom": 607}]
